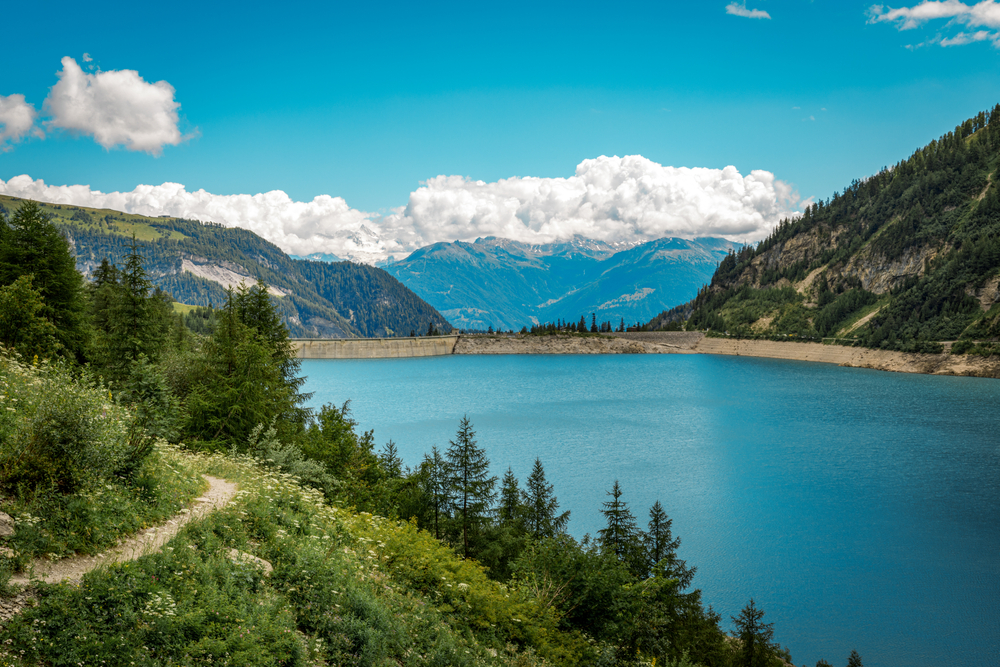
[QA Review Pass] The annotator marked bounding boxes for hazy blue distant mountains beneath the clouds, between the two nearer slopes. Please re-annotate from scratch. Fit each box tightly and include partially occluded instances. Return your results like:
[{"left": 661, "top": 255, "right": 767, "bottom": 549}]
[{"left": 385, "top": 236, "right": 741, "bottom": 329}]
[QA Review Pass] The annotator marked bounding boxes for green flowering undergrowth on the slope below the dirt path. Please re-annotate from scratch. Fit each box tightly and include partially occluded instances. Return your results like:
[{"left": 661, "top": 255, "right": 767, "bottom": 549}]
[{"left": 0, "top": 447, "right": 576, "bottom": 667}]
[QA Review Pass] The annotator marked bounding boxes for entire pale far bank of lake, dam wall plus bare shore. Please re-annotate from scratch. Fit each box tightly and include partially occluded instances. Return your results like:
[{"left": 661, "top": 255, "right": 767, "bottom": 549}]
[{"left": 291, "top": 331, "right": 1000, "bottom": 378}]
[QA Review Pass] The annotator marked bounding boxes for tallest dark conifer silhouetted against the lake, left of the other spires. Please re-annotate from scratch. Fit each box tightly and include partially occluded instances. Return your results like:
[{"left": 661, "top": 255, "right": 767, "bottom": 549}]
[{"left": 446, "top": 416, "right": 497, "bottom": 558}]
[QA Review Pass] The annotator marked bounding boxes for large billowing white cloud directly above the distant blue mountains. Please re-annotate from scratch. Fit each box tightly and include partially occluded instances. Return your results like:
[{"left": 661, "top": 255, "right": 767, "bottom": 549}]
[{"left": 385, "top": 155, "right": 795, "bottom": 250}]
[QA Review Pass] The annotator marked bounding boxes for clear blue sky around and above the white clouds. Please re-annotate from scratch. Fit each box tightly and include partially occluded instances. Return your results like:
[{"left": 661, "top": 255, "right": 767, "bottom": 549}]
[{"left": 0, "top": 0, "right": 1000, "bottom": 260}]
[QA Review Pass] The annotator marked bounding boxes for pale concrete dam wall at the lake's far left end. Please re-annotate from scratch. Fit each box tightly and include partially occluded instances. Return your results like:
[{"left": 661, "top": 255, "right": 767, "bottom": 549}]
[{"left": 289, "top": 336, "right": 458, "bottom": 359}]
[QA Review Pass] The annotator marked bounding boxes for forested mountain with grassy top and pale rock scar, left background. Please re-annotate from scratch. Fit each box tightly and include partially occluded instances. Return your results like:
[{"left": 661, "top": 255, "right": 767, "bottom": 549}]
[{"left": 0, "top": 196, "right": 450, "bottom": 337}]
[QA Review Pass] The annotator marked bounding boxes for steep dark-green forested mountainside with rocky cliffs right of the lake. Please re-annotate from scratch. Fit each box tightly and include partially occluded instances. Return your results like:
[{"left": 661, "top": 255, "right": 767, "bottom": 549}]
[{"left": 664, "top": 105, "right": 1000, "bottom": 354}]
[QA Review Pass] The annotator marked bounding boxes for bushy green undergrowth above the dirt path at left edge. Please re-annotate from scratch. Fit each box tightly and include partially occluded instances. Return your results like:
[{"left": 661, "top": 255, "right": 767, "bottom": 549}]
[{"left": 0, "top": 355, "right": 204, "bottom": 583}]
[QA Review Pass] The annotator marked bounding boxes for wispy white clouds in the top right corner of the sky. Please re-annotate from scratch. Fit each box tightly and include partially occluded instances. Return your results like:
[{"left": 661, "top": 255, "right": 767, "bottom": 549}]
[{"left": 868, "top": 0, "right": 1000, "bottom": 47}]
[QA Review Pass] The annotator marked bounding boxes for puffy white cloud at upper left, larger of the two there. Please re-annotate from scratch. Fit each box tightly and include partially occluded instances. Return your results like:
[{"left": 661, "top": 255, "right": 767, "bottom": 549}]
[{"left": 45, "top": 57, "right": 185, "bottom": 155}]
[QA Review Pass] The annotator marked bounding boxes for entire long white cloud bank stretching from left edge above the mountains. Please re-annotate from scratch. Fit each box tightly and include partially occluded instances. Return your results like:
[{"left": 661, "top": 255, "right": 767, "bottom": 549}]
[{"left": 0, "top": 156, "right": 805, "bottom": 262}]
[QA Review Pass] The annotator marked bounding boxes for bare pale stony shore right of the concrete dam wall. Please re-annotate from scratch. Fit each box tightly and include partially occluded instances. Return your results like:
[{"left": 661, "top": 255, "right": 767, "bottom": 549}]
[{"left": 454, "top": 331, "right": 1000, "bottom": 378}]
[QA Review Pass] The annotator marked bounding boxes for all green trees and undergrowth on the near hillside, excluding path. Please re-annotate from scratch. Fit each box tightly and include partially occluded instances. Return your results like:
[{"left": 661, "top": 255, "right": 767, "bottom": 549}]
[{"left": 0, "top": 202, "right": 861, "bottom": 667}]
